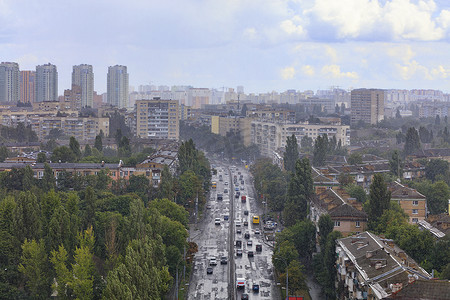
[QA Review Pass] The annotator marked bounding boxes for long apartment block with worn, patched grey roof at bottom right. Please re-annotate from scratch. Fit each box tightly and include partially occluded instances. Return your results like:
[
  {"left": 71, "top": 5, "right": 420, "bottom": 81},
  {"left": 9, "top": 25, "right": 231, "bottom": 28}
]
[{"left": 336, "top": 231, "right": 432, "bottom": 300}]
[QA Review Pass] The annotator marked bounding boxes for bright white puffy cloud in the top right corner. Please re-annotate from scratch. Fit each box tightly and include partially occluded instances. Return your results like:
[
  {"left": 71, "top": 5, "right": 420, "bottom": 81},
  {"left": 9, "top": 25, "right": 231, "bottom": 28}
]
[{"left": 305, "top": 0, "right": 450, "bottom": 41}]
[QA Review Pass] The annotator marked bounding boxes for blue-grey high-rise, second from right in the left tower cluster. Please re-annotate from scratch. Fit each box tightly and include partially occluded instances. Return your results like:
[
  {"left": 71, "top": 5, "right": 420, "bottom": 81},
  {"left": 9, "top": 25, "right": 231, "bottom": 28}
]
[{"left": 72, "top": 64, "right": 94, "bottom": 107}]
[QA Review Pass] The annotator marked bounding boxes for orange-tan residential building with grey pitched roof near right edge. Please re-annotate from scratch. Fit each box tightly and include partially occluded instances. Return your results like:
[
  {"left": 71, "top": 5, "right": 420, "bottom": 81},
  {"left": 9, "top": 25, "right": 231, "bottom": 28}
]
[{"left": 389, "top": 181, "right": 427, "bottom": 224}]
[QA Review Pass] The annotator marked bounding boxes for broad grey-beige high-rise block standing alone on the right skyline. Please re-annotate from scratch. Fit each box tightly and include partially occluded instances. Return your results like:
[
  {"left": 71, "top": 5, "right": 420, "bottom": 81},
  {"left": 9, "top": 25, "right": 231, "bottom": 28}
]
[{"left": 351, "top": 89, "right": 384, "bottom": 125}]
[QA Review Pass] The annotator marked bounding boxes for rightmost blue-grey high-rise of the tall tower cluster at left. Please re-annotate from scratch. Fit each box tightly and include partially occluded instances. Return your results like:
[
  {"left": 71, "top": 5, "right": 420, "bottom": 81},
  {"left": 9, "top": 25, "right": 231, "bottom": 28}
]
[{"left": 107, "top": 65, "right": 129, "bottom": 108}]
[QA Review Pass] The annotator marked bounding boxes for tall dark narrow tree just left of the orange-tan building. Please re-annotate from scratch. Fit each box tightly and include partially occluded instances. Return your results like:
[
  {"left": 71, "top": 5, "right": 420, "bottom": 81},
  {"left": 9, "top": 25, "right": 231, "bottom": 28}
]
[{"left": 366, "top": 174, "right": 391, "bottom": 229}]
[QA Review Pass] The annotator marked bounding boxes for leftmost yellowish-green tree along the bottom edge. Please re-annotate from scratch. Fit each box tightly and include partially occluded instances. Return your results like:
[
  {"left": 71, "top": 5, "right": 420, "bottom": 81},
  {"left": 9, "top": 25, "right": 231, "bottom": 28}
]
[{"left": 19, "top": 239, "right": 50, "bottom": 299}]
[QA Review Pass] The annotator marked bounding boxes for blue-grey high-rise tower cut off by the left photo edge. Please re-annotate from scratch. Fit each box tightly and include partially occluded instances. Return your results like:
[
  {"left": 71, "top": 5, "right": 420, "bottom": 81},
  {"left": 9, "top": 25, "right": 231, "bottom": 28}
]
[{"left": 0, "top": 62, "right": 19, "bottom": 103}]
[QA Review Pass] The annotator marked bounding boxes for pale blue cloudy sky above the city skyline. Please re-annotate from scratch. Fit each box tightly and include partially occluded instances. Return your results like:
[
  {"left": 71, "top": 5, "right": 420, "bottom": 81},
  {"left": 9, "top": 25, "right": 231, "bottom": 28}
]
[{"left": 0, "top": 0, "right": 450, "bottom": 93}]
